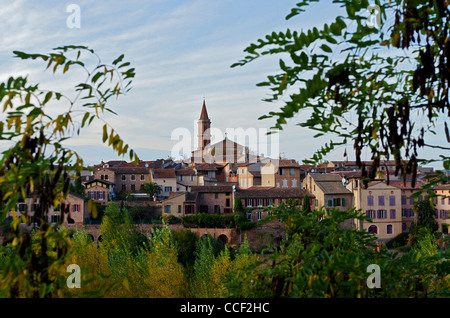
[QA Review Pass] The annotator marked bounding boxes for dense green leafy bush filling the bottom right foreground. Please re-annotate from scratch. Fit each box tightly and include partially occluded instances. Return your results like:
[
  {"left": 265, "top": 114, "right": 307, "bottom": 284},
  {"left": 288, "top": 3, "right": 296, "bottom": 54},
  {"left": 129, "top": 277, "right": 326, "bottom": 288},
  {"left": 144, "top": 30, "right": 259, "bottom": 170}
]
[{"left": 224, "top": 205, "right": 450, "bottom": 298}]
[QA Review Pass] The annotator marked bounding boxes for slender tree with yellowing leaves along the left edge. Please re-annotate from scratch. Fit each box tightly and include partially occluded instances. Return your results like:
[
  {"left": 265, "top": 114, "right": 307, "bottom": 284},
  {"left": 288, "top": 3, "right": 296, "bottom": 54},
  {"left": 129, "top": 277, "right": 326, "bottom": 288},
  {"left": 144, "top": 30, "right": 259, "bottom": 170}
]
[{"left": 0, "top": 45, "right": 135, "bottom": 297}]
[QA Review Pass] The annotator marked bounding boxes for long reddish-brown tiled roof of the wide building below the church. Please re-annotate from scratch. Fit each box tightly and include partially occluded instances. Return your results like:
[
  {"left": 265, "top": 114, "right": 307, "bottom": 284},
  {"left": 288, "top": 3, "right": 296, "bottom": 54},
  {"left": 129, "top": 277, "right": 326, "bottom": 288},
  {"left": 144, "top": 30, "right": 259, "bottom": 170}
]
[{"left": 235, "top": 187, "right": 314, "bottom": 199}]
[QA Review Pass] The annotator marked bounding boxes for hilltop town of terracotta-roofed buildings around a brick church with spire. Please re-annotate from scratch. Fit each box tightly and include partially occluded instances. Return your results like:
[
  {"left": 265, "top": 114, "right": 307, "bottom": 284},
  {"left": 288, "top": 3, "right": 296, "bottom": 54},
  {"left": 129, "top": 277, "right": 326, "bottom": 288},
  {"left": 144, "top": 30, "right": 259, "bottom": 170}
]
[{"left": 4, "top": 101, "right": 450, "bottom": 248}]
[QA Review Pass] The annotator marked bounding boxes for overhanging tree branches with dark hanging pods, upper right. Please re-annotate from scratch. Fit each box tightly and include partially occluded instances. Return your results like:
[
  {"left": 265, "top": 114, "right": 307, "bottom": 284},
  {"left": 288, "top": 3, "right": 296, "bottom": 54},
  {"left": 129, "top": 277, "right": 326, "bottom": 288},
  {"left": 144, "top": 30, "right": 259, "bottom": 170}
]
[{"left": 232, "top": 0, "right": 450, "bottom": 183}]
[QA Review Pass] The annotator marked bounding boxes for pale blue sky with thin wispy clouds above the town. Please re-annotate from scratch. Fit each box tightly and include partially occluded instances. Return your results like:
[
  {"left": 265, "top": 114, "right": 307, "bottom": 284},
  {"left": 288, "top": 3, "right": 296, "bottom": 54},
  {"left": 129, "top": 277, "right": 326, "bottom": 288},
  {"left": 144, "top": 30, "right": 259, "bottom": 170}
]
[{"left": 0, "top": 0, "right": 443, "bottom": 169}]
